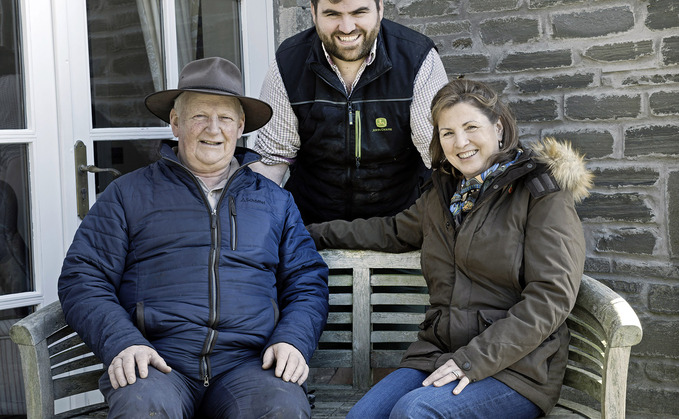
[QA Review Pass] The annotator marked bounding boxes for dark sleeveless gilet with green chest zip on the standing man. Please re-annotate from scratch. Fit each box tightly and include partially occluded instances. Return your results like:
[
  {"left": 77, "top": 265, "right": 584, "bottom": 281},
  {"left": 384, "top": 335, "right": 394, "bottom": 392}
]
[{"left": 276, "top": 19, "right": 434, "bottom": 224}]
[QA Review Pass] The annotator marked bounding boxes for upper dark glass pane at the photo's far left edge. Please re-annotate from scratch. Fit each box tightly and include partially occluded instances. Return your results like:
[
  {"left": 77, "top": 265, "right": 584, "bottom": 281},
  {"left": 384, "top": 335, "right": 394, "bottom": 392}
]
[{"left": 0, "top": 0, "right": 26, "bottom": 129}]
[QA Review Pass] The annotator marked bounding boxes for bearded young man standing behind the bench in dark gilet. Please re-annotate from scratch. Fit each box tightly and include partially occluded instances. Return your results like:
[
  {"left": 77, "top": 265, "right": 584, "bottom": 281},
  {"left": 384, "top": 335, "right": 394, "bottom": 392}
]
[{"left": 253, "top": 0, "right": 448, "bottom": 224}]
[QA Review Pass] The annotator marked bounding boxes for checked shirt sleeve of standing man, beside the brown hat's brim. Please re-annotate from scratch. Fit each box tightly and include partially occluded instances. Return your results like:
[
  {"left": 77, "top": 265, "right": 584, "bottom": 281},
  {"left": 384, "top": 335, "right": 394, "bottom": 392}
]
[{"left": 253, "top": 60, "right": 301, "bottom": 165}]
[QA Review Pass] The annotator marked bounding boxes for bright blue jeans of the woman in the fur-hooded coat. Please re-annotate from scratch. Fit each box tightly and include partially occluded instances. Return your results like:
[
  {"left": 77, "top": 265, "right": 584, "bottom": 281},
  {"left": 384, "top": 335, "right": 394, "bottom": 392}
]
[{"left": 347, "top": 368, "right": 542, "bottom": 419}]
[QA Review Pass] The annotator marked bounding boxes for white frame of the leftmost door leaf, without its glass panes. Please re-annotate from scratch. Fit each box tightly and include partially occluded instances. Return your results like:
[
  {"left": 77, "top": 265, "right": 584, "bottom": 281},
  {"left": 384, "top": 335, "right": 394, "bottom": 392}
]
[{"left": 0, "top": 0, "right": 64, "bottom": 310}]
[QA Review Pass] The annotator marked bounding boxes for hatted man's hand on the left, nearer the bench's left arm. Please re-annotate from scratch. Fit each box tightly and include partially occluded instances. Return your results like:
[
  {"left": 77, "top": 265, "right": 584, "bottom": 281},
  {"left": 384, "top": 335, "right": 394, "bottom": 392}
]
[{"left": 108, "top": 345, "right": 172, "bottom": 389}]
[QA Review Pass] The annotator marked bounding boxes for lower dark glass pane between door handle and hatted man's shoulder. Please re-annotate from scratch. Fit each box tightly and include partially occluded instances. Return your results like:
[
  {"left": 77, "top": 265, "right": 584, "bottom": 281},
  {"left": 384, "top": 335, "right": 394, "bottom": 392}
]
[{"left": 94, "top": 140, "right": 170, "bottom": 195}]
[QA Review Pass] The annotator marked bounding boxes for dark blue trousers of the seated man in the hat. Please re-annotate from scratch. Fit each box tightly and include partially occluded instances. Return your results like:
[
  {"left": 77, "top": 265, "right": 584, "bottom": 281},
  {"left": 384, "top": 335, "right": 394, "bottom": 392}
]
[{"left": 99, "top": 359, "right": 311, "bottom": 419}]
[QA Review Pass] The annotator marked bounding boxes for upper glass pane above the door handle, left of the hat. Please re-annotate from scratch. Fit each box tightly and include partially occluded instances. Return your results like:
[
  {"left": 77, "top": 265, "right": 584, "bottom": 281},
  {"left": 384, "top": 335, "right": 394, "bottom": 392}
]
[{"left": 87, "top": 0, "right": 165, "bottom": 128}]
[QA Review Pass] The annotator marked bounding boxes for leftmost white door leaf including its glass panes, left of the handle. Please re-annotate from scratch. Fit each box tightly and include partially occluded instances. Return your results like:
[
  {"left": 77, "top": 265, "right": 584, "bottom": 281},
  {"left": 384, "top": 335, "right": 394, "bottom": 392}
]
[{"left": 0, "top": 0, "right": 63, "bottom": 417}]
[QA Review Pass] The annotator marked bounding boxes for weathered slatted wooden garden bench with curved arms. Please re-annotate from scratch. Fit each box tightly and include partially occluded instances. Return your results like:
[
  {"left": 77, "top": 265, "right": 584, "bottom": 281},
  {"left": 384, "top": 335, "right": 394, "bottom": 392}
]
[{"left": 11, "top": 250, "right": 642, "bottom": 418}]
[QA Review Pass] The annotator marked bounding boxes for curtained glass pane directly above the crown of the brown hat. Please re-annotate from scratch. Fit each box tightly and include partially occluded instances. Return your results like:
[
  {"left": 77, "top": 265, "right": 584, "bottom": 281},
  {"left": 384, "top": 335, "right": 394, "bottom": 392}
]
[{"left": 175, "top": 0, "right": 242, "bottom": 70}]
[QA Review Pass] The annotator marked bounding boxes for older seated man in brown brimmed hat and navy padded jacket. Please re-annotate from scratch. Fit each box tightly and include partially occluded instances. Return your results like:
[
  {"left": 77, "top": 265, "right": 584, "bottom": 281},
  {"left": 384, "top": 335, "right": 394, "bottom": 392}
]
[{"left": 59, "top": 58, "right": 328, "bottom": 418}]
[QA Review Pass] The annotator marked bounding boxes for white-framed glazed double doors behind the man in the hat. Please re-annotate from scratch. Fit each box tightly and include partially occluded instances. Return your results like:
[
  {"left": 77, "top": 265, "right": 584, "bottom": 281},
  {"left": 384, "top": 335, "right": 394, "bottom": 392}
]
[{"left": 0, "top": 0, "right": 274, "bottom": 418}]
